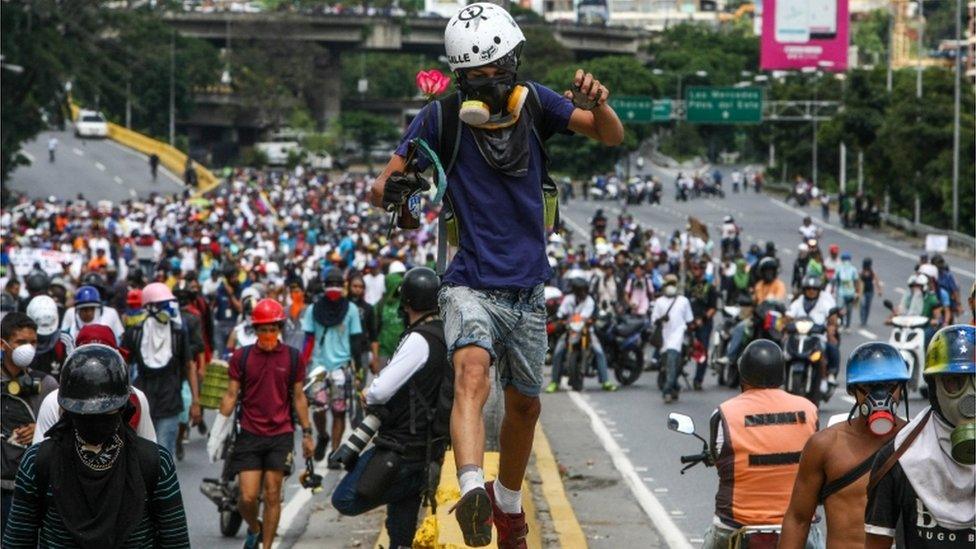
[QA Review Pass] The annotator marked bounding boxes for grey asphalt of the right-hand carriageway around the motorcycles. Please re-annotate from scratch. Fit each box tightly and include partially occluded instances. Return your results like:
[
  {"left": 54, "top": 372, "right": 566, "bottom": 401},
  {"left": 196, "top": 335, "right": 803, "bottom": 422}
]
[{"left": 559, "top": 164, "right": 974, "bottom": 546}]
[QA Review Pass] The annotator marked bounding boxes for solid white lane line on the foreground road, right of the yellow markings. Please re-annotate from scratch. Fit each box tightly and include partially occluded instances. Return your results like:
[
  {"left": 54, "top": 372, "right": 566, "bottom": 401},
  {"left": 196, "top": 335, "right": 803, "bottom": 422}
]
[{"left": 569, "top": 393, "right": 691, "bottom": 549}]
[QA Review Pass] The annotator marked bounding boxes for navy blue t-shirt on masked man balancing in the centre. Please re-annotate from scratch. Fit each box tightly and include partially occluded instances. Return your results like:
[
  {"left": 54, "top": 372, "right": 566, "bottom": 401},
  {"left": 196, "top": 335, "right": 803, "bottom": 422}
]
[{"left": 396, "top": 83, "right": 573, "bottom": 289}]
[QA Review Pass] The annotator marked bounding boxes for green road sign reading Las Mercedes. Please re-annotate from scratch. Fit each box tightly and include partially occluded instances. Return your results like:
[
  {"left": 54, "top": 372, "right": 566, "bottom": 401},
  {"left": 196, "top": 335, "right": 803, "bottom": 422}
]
[{"left": 685, "top": 86, "right": 763, "bottom": 124}]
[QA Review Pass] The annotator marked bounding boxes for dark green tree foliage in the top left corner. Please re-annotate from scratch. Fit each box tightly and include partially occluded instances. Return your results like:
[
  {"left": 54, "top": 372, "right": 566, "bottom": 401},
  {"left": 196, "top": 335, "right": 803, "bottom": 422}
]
[{"left": 0, "top": 0, "right": 217, "bottom": 179}]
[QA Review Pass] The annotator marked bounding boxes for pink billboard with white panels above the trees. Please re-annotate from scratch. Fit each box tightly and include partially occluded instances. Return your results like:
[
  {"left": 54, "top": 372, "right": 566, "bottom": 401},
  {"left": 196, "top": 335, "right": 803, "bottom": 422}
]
[{"left": 760, "top": 0, "right": 848, "bottom": 72}]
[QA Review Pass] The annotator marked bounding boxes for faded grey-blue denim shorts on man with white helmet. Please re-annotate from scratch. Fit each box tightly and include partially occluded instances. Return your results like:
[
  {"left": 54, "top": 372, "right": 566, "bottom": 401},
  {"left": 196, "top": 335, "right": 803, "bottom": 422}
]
[{"left": 438, "top": 284, "right": 549, "bottom": 397}]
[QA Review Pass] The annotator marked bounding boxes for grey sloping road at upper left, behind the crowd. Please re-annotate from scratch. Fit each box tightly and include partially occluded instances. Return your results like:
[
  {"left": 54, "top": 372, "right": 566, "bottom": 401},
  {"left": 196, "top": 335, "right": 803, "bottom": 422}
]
[{"left": 6, "top": 129, "right": 184, "bottom": 202}]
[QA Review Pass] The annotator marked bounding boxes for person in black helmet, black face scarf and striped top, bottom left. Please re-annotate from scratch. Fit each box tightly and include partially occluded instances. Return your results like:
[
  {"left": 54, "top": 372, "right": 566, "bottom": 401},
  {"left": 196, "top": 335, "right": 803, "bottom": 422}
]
[{"left": 3, "top": 343, "right": 190, "bottom": 549}]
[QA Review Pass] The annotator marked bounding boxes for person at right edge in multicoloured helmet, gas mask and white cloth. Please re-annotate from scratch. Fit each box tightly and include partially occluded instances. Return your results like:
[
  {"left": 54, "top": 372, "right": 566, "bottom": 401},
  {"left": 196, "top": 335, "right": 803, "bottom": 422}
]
[{"left": 864, "top": 324, "right": 976, "bottom": 549}]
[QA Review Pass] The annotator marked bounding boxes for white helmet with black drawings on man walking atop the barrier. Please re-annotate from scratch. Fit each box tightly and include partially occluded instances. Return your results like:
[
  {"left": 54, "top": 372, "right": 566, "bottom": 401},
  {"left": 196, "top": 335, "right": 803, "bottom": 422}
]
[{"left": 444, "top": 2, "right": 525, "bottom": 71}]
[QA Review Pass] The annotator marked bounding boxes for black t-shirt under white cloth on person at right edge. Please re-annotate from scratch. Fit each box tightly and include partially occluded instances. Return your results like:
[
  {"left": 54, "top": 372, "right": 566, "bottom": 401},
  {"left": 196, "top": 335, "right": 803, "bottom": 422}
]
[{"left": 864, "top": 441, "right": 976, "bottom": 549}]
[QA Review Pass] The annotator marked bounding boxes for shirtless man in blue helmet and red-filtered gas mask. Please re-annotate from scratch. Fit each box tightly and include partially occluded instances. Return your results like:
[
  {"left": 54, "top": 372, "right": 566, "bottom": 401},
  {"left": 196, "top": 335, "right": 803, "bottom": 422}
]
[{"left": 779, "top": 343, "right": 910, "bottom": 549}]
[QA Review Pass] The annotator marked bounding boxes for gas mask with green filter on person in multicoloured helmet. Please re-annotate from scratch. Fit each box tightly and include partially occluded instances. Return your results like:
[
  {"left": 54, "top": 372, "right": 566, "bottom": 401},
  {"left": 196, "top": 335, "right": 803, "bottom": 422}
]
[{"left": 930, "top": 374, "right": 976, "bottom": 465}]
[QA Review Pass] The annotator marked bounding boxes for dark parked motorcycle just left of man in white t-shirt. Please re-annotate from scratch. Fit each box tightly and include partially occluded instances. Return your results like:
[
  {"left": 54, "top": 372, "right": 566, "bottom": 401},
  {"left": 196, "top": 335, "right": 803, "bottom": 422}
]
[{"left": 593, "top": 311, "right": 650, "bottom": 385}]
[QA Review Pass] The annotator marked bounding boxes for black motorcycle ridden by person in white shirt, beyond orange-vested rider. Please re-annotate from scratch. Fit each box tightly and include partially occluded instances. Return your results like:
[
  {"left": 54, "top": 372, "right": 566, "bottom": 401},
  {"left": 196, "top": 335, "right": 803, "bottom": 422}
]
[{"left": 784, "top": 317, "right": 827, "bottom": 406}]
